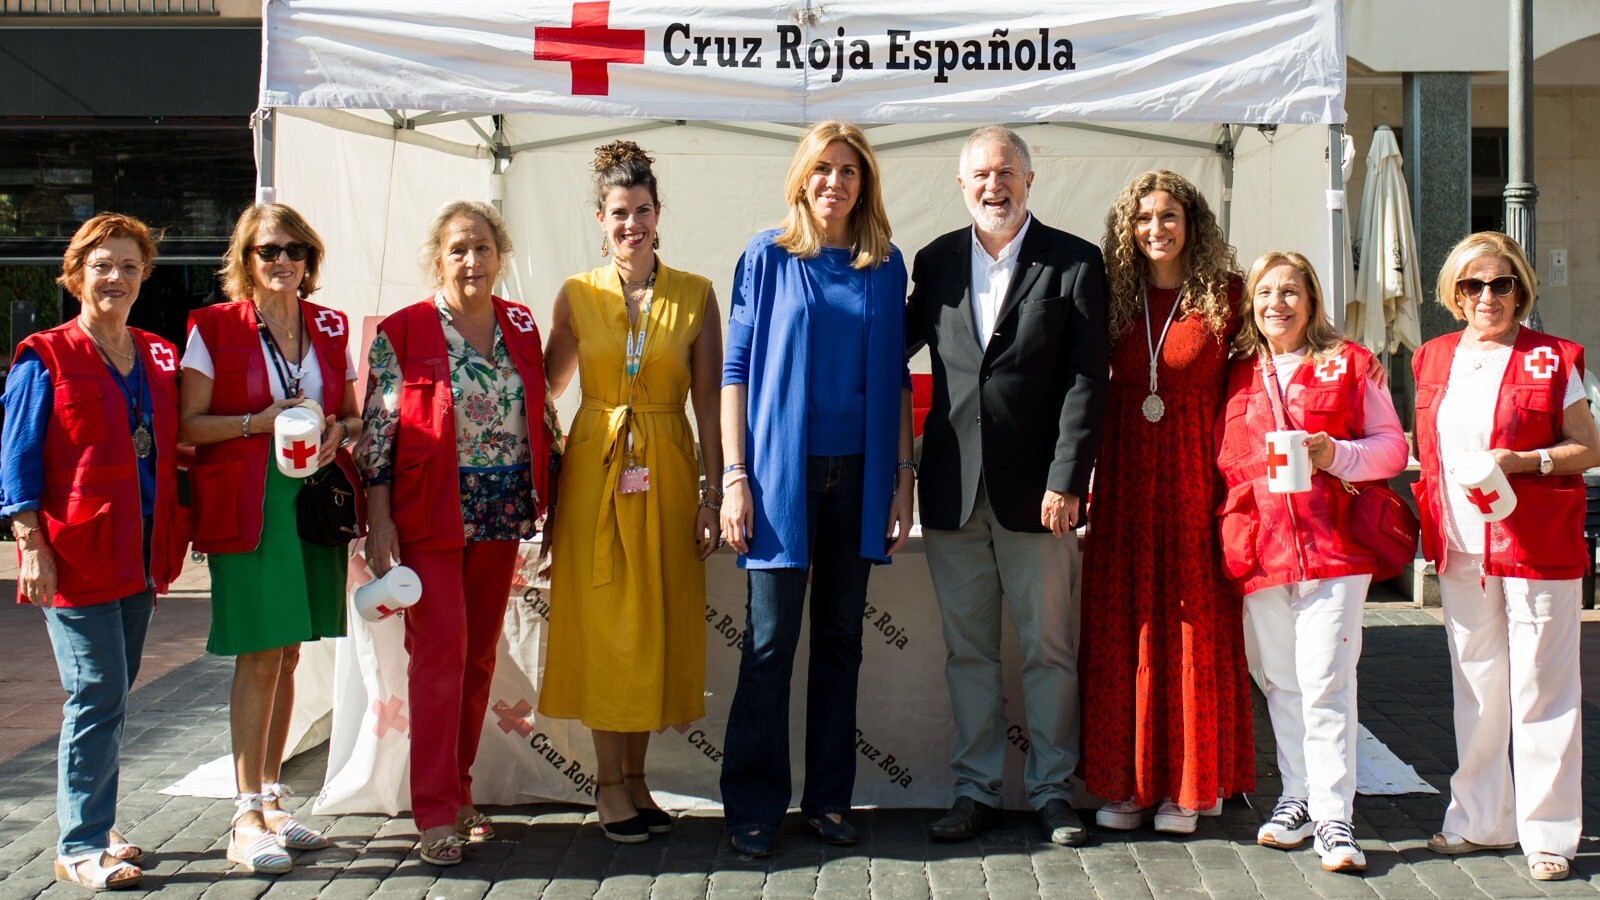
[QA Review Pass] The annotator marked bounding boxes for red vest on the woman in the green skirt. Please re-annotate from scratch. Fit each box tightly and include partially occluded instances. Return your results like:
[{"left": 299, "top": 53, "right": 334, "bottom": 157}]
[{"left": 189, "top": 299, "right": 366, "bottom": 552}]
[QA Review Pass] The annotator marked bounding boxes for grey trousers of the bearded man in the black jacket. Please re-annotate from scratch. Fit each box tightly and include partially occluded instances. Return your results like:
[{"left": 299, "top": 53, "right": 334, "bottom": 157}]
[{"left": 923, "top": 482, "right": 1078, "bottom": 809}]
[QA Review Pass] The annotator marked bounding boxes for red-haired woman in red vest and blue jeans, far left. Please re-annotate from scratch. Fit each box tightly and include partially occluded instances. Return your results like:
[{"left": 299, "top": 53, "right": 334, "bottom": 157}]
[{"left": 0, "top": 215, "right": 189, "bottom": 890}]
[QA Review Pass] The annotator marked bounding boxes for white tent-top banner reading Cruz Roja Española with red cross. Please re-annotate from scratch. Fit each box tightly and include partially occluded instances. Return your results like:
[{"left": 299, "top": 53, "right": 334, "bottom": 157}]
[{"left": 261, "top": 0, "right": 1344, "bottom": 125}]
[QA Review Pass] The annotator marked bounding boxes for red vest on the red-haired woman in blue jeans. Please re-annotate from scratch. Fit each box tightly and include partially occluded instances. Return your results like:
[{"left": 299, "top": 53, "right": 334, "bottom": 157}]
[{"left": 18, "top": 319, "right": 189, "bottom": 607}]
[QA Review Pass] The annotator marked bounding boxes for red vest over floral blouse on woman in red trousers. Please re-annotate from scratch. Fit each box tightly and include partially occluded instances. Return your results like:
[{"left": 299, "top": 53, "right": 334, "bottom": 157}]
[{"left": 378, "top": 296, "right": 550, "bottom": 549}]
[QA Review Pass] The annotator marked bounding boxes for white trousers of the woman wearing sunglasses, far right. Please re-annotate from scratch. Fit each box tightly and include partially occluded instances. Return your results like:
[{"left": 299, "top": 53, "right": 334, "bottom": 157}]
[{"left": 1438, "top": 552, "right": 1584, "bottom": 860}]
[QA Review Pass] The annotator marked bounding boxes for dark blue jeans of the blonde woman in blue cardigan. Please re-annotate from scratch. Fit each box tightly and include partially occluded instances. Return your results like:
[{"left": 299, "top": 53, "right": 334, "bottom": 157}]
[{"left": 722, "top": 455, "right": 872, "bottom": 831}]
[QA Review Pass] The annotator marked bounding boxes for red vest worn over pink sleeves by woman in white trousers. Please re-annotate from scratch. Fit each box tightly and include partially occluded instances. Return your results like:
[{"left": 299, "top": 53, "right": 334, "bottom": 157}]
[{"left": 1216, "top": 343, "right": 1379, "bottom": 594}]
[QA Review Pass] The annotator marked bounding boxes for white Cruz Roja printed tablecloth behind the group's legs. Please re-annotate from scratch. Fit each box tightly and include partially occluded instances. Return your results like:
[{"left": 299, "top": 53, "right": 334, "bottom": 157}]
[{"left": 315, "top": 540, "right": 1027, "bottom": 815}]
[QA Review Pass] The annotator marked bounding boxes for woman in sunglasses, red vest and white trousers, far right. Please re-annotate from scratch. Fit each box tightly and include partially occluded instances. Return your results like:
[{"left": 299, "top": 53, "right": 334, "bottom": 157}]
[{"left": 1411, "top": 231, "right": 1600, "bottom": 881}]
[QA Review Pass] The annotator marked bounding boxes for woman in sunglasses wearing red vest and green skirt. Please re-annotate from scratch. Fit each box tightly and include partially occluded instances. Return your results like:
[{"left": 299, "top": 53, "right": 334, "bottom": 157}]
[{"left": 181, "top": 203, "right": 362, "bottom": 873}]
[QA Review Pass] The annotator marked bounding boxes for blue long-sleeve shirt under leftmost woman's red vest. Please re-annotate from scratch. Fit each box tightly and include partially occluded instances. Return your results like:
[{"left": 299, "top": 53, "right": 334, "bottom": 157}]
[{"left": 0, "top": 349, "right": 155, "bottom": 516}]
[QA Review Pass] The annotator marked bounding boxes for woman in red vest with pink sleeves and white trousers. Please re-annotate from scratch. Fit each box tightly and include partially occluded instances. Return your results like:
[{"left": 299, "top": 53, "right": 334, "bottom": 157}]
[{"left": 1216, "top": 251, "right": 1406, "bottom": 871}]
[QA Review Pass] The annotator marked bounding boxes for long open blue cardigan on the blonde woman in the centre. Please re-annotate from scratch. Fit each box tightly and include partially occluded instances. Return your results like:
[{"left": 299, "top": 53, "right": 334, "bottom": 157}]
[{"left": 722, "top": 229, "right": 910, "bottom": 569}]
